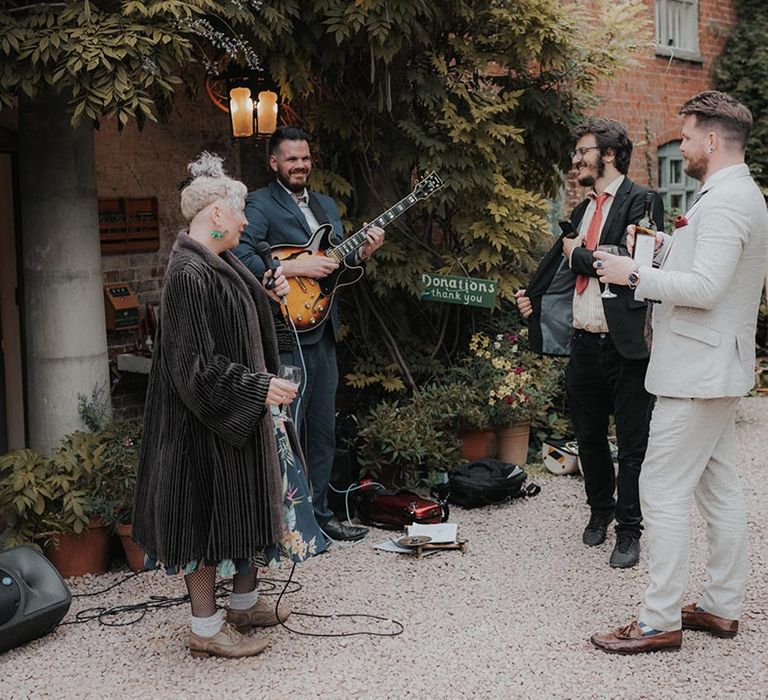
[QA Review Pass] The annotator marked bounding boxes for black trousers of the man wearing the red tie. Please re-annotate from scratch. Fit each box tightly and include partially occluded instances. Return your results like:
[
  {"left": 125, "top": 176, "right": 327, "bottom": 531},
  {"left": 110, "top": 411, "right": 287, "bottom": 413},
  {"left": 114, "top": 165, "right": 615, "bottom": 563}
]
[{"left": 565, "top": 330, "right": 654, "bottom": 537}]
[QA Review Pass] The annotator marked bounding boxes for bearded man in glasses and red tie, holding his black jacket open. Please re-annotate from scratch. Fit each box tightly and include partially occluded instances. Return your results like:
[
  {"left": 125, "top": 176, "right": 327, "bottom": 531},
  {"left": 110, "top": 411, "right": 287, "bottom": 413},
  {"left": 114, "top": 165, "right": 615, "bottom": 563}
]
[{"left": 516, "top": 118, "right": 664, "bottom": 568}]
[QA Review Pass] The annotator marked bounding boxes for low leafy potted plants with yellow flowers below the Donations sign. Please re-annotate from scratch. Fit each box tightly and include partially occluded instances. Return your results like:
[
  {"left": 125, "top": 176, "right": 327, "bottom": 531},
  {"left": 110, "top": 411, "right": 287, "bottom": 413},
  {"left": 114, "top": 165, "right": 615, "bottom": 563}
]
[{"left": 358, "top": 306, "right": 568, "bottom": 490}]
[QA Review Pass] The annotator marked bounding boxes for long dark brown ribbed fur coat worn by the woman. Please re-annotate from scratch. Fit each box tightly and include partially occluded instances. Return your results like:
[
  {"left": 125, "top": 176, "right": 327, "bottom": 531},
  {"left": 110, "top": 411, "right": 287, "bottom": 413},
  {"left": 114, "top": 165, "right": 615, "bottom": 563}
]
[{"left": 133, "top": 233, "right": 282, "bottom": 566}]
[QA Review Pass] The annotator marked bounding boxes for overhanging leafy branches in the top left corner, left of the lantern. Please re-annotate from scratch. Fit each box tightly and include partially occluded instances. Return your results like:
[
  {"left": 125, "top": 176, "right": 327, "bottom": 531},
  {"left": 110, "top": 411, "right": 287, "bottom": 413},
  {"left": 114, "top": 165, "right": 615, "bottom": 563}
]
[{"left": 0, "top": 0, "right": 268, "bottom": 126}]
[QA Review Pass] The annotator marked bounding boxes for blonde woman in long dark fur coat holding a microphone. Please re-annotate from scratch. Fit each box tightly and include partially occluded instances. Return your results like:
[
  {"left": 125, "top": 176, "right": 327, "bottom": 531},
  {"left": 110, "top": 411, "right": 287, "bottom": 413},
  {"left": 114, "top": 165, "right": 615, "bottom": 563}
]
[{"left": 133, "top": 153, "right": 326, "bottom": 658}]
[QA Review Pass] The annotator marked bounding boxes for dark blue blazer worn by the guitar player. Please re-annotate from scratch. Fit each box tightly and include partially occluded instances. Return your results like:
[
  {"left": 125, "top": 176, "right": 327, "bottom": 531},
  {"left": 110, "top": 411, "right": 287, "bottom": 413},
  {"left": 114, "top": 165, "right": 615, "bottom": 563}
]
[{"left": 234, "top": 180, "right": 343, "bottom": 345}]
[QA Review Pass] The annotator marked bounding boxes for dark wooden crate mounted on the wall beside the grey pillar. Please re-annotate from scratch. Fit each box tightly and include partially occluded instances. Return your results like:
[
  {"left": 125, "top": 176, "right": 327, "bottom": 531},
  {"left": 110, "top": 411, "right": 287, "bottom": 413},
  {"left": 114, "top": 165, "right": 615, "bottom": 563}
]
[{"left": 99, "top": 197, "right": 160, "bottom": 255}]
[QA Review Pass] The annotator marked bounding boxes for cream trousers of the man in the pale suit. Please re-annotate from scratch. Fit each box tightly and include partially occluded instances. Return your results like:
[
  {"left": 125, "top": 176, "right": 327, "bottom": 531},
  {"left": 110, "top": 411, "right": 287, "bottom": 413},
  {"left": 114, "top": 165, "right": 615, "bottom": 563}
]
[{"left": 639, "top": 397, "right": 747, "bottom": 631}]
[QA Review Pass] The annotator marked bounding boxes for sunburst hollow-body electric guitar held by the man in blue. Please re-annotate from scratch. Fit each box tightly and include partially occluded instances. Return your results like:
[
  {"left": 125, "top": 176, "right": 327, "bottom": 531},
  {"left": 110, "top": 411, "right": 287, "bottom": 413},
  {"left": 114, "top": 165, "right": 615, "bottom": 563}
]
[{"left": 272, "top": 173, "right": 444, "bottom": 333}]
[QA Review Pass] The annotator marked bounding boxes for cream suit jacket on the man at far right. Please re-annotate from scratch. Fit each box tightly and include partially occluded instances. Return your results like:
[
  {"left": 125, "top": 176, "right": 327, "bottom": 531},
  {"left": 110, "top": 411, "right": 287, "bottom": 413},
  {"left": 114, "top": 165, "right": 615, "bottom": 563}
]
[{"left": 635, "top": 164, "right": 768, "bottom": 399}]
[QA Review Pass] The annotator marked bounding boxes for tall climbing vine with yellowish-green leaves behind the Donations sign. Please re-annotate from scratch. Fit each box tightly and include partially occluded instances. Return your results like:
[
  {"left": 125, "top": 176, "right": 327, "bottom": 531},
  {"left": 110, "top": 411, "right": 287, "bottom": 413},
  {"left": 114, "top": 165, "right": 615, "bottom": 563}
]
[{"left": 243, "top": 0, "right": 646, "bottom": 398}]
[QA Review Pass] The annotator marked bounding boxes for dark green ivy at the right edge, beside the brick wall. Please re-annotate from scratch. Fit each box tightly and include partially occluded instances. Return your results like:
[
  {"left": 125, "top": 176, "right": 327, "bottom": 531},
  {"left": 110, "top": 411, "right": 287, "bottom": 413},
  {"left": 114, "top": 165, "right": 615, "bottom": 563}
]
[{"left": 714, "top": 0, "right": 768, "bottom": 194}]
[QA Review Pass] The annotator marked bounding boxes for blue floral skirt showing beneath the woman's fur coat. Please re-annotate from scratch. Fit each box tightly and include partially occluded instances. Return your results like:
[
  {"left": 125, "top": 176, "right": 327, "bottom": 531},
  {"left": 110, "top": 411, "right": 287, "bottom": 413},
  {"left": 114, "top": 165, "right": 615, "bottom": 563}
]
[{"left": 144, "top": 406, "right": 328, "bottom": 578}]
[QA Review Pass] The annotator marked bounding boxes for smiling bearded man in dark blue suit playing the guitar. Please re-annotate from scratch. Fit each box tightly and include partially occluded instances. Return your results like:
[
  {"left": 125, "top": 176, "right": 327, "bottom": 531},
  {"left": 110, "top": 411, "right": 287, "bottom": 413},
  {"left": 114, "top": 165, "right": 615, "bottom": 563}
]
[{"left": 234, "top": 126, "right": 384, "bottom": 540}]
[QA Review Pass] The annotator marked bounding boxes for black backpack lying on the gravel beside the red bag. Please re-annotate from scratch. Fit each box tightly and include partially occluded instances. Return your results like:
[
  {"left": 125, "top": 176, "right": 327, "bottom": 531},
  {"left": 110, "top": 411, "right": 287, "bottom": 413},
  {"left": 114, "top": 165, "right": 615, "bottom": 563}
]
[{"left": 448, "top": 458, "right": 541, "bottom": 508}]
